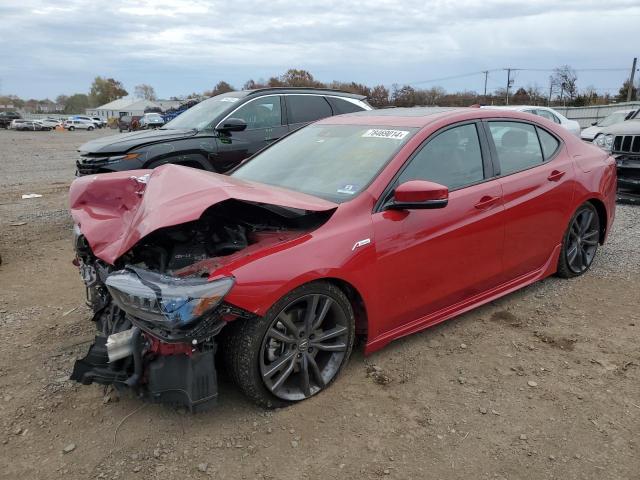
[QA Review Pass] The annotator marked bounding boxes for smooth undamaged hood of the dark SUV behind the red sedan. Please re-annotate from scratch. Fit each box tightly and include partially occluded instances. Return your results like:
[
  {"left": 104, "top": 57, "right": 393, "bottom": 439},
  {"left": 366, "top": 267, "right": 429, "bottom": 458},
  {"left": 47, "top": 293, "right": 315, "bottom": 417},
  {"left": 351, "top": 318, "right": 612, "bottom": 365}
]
[{"left": 78, "top": 129, "right": 198, "bottom": 155}]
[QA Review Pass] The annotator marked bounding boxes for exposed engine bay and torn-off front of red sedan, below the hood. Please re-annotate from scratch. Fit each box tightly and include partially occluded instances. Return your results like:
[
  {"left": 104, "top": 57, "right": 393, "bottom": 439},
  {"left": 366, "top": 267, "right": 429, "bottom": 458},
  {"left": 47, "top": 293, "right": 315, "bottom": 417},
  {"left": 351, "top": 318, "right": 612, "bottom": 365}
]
[{"left": 71, "top": 199, "right": 332, "bottom": 411}]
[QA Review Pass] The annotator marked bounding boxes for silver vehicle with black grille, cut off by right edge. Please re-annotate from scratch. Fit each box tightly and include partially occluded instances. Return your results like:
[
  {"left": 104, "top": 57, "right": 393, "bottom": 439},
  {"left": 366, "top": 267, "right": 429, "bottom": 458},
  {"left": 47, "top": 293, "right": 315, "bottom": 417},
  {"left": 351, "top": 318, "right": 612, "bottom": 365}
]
[{"left": 593, "top": 109, "right": 640, "bottom": 199}]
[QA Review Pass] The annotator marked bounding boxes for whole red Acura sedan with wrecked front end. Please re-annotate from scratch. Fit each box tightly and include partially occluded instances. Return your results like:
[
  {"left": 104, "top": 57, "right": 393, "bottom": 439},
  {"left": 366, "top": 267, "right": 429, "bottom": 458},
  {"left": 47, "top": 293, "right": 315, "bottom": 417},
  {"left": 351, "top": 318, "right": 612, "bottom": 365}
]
[{"left": 70, "top": 108, "right": 616, "bottom": 409}]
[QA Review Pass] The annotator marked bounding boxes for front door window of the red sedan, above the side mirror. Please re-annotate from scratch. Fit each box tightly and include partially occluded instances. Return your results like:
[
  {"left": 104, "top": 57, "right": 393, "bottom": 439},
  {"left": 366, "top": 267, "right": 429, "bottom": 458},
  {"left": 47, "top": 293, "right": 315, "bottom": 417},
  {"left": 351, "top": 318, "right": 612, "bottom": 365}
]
[{"left": 399, "top": 124, "right": 484, "bottom": 190}]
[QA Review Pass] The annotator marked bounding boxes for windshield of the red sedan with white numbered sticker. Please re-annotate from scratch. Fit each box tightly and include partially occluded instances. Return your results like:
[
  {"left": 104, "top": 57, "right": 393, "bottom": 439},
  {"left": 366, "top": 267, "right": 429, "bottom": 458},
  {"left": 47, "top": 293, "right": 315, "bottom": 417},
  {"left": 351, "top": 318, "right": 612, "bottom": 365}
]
[{"left": 232, "top": 124, "right": 417, "bottom": 203}]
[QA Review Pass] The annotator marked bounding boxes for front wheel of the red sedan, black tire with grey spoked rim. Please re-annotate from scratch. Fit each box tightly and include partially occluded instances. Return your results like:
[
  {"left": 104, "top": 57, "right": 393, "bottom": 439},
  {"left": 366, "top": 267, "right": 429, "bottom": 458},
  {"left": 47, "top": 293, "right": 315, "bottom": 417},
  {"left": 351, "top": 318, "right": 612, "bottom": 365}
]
[{"left": 221, "top": 281, "right": 355, "bottom": 408}]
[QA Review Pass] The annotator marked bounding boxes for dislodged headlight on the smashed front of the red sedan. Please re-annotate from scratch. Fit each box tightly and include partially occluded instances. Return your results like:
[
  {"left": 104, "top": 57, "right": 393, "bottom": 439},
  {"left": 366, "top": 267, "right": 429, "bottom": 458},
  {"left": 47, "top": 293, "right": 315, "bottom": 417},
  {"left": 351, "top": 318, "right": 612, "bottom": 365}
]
[{"left": 105, "top": 267, "right": 234, "bottom": 328}]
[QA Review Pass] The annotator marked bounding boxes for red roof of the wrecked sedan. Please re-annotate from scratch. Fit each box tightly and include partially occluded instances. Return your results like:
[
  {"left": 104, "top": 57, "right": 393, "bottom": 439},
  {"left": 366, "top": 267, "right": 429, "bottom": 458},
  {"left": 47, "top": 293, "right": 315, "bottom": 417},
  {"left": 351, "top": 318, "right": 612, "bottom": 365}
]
[{"left": 316, "top": 107, "right": 560, "bottom": 128}]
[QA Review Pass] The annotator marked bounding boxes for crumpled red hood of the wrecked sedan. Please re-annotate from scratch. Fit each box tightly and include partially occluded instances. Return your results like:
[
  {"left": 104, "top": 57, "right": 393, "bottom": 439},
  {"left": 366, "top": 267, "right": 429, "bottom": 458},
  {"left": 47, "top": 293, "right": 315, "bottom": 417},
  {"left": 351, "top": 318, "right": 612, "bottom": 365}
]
[{"left": 69, "top": 164, "right": 338, "bottom": 264}]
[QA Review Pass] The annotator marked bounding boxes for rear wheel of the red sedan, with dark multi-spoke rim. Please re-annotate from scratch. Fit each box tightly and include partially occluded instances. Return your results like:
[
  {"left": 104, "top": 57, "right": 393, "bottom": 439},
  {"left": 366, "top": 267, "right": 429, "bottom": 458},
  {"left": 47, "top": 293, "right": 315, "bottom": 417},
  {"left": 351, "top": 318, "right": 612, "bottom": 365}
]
[{"left": 557, "top": 202, "right": 600, "bottom": 278}]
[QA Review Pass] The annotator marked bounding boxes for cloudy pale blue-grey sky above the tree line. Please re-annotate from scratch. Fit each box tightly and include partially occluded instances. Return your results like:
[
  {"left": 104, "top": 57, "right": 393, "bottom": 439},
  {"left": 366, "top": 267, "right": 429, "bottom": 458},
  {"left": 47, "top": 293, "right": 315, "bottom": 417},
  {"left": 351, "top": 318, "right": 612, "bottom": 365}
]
[{"left": 0, "top": 0, "right": 640, "bottom": 98}]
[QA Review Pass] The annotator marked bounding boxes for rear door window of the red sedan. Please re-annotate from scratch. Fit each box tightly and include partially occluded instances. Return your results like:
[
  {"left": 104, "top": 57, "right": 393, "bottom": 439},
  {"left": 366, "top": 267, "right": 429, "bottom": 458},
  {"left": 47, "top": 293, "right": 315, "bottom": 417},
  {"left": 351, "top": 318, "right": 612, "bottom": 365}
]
[{"left": 489, "top": 122, "right": 543, "bottom": 175}]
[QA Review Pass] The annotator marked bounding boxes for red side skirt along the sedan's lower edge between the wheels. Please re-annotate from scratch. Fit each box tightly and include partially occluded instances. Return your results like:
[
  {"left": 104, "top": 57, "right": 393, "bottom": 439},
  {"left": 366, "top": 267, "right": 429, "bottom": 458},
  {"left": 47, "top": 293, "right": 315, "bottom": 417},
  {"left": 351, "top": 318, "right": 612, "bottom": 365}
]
[{"left": 364, "top": 245, "right": 562, "bottom": 355}]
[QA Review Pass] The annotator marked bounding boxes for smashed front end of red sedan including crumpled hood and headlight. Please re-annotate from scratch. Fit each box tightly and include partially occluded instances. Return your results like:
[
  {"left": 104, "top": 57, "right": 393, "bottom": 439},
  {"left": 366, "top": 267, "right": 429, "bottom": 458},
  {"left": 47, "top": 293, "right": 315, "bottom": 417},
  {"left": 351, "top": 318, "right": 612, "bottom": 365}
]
[{"left": 69, "top": 165, "right": 336, "bottom": 411}]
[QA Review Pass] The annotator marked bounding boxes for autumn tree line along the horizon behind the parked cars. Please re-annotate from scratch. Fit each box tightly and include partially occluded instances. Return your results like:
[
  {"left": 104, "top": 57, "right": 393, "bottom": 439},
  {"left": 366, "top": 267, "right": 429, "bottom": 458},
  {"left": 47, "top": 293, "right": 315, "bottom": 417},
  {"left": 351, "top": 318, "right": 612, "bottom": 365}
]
[{"left": 0, "top": 65, "right": 639, "bottom": 113}]
